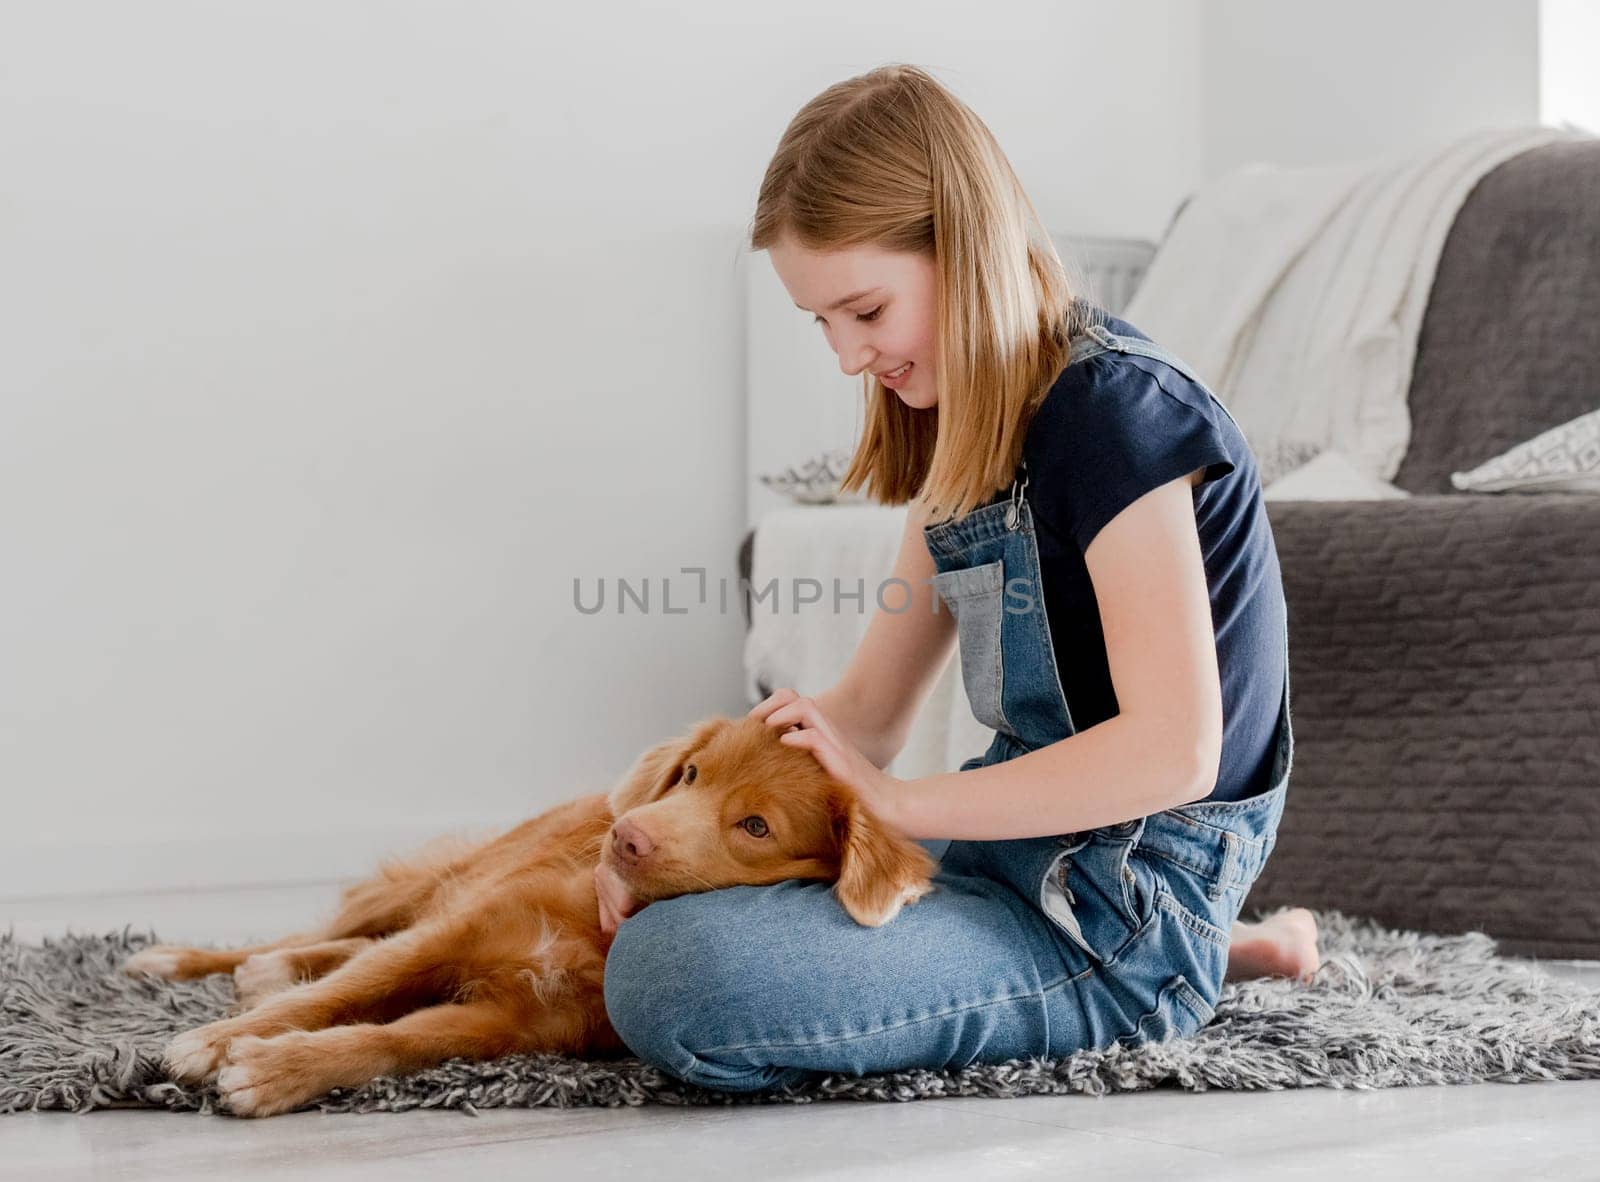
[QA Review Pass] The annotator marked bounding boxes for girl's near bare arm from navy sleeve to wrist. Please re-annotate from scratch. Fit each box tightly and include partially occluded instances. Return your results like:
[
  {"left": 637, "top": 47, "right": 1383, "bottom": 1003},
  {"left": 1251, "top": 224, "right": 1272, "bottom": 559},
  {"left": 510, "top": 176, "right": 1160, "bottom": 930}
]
[{"left": 883, "top": 472, "right": 1222, "bottom": 841}]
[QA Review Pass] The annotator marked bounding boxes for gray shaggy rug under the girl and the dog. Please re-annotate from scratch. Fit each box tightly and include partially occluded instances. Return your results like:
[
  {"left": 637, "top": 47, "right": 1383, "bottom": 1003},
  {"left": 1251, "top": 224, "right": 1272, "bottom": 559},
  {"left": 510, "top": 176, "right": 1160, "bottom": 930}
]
[{"left": 0, "top": 912, "right": 1600, "bottom": 1113}]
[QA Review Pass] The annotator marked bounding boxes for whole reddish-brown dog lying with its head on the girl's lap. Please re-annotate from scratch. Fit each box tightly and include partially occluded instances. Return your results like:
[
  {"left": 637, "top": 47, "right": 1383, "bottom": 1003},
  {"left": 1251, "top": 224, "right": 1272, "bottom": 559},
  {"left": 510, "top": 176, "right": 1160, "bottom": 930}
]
[{"left": 125, "top": 718, "right": 933, "bottom": 1116}]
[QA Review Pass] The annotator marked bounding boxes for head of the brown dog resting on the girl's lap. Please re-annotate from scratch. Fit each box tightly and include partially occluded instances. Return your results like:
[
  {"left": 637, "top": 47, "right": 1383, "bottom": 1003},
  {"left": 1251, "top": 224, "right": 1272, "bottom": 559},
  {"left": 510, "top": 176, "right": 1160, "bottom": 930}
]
[{"left": 602, "top": 718, "right": 934, "bottom": 928}]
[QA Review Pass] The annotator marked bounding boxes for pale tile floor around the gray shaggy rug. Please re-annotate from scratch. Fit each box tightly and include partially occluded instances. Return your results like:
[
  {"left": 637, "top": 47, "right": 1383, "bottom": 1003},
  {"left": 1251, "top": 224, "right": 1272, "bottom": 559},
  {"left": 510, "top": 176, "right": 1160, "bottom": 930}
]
[{"left": 0, "top": 885, "right": 1600, "bottom": 1182}]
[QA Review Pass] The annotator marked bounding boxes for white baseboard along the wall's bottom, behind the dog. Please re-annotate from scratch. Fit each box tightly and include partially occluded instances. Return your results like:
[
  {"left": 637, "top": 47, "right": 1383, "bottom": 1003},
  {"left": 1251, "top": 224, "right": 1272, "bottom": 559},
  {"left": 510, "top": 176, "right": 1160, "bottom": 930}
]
[{"left": 0, "top": 817, "right": 520, "bottom": 900}]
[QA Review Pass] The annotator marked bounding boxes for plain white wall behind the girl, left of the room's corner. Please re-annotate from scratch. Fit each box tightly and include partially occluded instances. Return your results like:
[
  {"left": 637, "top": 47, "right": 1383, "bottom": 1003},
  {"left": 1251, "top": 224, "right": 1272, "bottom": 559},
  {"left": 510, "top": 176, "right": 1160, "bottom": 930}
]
[{"left": 0, "top": 0, "right": 1200, "bottom": 899}]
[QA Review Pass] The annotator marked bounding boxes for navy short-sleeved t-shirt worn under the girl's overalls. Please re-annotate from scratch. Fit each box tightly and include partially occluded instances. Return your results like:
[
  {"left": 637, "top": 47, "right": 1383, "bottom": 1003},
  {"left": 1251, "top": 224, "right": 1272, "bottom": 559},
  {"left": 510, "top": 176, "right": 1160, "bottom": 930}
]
[{"left": 1022, "top": 312, "right": 1285, "bottom": 800}]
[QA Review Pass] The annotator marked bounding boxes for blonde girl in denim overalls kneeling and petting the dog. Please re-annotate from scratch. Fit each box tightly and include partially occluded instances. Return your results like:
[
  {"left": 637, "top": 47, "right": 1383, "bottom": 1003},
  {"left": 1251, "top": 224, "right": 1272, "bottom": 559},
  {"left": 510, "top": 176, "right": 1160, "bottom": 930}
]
[{"left": 597, "top": 66, "right": 1317, "bottom": 1091}]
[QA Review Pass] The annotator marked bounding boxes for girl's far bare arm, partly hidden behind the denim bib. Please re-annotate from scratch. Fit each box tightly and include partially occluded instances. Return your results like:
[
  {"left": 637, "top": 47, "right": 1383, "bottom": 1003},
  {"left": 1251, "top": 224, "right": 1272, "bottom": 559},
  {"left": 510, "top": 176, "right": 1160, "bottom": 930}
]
[{"left": 814, "top": 501, "right": 955, "bottom": 768}]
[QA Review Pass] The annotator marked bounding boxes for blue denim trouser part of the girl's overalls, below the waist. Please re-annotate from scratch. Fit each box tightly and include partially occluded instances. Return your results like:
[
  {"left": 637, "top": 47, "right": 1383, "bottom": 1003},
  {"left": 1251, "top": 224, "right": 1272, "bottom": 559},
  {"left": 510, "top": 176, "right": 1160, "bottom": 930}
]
[{"left": 605, "top": 782, "right": 1285, "bottom": 1092}]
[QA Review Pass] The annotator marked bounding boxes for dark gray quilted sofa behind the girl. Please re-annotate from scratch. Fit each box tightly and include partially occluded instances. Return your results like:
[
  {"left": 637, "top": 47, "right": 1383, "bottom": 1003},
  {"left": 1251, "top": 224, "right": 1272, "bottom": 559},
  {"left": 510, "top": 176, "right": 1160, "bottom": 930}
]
[{"left": 739, "top": 141, "right": 1600, "bottom": 958}]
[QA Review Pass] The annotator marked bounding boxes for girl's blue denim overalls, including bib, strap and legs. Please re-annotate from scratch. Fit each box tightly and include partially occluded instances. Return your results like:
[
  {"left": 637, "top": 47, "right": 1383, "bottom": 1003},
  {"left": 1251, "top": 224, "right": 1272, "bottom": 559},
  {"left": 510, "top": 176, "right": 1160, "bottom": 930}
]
[{"left": 605, "top": 326, "right": 1293, "bottom": 1092}]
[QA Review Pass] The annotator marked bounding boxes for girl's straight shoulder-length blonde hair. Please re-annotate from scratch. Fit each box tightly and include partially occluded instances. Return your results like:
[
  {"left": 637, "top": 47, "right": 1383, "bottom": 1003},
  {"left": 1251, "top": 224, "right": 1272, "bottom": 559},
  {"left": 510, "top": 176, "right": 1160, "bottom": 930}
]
[{"left": 750, "top": 66, "right": 1090, "bottom": 520}]
